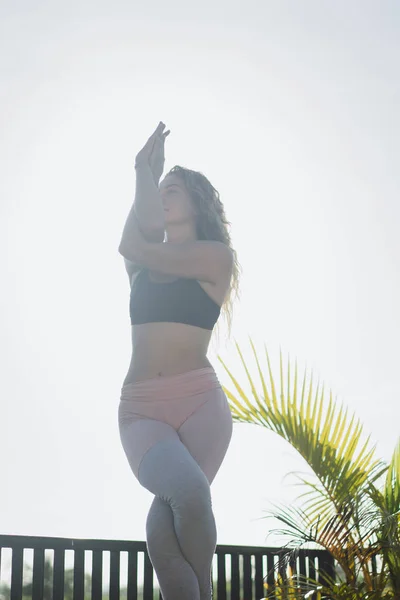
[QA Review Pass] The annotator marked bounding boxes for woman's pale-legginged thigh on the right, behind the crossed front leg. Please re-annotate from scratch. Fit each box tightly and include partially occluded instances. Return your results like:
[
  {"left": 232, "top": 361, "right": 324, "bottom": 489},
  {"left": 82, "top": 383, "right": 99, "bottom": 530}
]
[{"left": 178, "top": 389, "right": 233, "bottom": 484}]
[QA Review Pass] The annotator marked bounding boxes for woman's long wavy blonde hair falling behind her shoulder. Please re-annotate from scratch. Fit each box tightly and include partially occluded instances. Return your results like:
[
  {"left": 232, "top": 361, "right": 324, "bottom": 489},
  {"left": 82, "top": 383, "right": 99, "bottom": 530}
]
[{"left": 167, "top": 165, "right": 242, "bottom": 337}]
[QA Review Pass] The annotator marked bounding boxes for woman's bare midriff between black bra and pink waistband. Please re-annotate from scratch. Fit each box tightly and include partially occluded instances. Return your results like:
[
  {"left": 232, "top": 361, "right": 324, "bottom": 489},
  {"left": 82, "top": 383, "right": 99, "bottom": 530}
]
[{"left": 123, "top": 323, "right": 212, "bottom": 385}]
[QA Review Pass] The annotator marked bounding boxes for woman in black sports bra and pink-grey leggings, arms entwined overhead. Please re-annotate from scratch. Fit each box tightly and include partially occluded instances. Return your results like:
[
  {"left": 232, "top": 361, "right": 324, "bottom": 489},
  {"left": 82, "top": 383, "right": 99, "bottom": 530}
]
[{"left": 118, "top": 123, "right": 240, "bottom": 600}]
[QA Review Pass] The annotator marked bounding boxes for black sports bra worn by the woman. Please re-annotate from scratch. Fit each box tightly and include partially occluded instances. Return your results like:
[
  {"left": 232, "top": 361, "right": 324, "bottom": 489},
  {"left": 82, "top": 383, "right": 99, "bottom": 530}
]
[{"left": 129, "top": 269, "right": 221, "bottom": 330}]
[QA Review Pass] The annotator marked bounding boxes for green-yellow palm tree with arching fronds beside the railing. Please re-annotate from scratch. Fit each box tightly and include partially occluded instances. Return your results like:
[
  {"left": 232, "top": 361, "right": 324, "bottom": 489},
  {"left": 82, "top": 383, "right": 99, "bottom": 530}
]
[{"left": 218, "top": 338, "right": 400, "bottom": 600}]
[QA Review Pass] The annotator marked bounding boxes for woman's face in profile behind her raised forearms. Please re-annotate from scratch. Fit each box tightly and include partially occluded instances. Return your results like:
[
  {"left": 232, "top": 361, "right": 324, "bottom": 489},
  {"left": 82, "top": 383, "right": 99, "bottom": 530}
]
[{"left": 159, "top": 174, "right": 195, "bottom": 229}]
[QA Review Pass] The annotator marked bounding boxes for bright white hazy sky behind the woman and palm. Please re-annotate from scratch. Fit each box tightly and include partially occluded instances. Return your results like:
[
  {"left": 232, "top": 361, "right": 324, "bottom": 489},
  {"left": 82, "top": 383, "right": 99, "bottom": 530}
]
[{"left": 0, "top": 0, "right": 400, "bottom": 580}]
